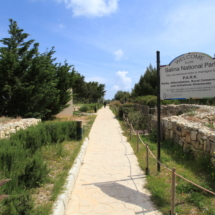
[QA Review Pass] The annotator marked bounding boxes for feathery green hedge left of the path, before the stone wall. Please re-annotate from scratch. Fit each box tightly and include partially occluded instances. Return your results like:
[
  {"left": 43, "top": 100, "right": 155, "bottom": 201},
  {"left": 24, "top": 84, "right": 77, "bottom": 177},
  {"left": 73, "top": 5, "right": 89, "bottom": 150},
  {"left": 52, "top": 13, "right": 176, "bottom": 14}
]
[{"left": 0, "top": 121, "right": 77, "bottom": 194}]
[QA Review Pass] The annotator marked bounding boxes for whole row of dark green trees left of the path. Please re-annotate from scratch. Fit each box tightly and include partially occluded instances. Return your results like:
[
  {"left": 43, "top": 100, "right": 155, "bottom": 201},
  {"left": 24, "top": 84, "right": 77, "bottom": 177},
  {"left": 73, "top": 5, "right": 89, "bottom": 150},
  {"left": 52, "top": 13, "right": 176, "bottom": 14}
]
[{"left": 0, "top": 19, "right": 105, "bottom": 119}]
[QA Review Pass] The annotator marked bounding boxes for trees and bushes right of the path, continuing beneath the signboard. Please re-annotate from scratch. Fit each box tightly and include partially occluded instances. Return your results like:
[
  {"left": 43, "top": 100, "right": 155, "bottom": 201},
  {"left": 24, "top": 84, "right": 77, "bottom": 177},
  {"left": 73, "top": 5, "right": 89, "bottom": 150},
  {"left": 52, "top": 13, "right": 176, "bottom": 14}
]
[{"left": 114, "top": 64, "right": 215, "bottom": 106}]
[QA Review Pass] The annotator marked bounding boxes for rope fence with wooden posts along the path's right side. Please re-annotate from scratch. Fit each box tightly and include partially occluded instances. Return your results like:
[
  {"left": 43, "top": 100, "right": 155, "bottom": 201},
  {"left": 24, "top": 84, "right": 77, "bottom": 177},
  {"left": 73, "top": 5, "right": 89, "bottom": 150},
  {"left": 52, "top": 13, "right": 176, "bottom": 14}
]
[{"left": 123, "top": 115, "right": 215, "bottom": 215}]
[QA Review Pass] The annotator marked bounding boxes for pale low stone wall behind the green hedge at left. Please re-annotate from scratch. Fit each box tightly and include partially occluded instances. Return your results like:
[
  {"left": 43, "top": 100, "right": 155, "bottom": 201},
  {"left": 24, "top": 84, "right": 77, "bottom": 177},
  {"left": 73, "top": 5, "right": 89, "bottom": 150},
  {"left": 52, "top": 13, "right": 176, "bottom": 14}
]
[{"left": 0, "top": 118, "right": 41, "bottom": 139}]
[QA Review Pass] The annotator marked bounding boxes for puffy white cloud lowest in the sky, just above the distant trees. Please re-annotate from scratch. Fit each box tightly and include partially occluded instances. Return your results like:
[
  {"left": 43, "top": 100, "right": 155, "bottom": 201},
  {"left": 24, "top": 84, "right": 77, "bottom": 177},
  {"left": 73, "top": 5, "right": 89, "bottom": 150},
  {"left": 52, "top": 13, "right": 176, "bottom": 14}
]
[{"left": 112, "top": 71, "right": 132, "bottom": 91}]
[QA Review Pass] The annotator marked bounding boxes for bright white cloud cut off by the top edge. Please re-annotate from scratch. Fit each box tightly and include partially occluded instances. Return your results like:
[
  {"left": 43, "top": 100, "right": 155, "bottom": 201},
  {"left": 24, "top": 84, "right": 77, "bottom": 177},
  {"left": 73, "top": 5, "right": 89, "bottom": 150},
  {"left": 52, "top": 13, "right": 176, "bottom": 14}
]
[{"left": 56, "top": 0, "right": 119, "bottom": 17}]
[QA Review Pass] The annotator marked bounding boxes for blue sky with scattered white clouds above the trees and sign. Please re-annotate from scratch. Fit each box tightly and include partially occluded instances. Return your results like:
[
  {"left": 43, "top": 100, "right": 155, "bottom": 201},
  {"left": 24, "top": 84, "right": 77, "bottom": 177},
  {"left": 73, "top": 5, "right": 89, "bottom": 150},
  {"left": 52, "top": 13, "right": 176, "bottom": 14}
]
[{"left": 0, "top": 0, "right": 215, "bottom": 99}]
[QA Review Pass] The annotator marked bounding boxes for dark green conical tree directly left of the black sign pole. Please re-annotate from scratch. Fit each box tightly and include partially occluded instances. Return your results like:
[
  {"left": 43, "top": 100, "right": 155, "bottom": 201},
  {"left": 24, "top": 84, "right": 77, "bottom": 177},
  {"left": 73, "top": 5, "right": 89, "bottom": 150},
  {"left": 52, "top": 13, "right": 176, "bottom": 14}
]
[{"left": 131, "top": 64, "right": 157, "bottom": 97}]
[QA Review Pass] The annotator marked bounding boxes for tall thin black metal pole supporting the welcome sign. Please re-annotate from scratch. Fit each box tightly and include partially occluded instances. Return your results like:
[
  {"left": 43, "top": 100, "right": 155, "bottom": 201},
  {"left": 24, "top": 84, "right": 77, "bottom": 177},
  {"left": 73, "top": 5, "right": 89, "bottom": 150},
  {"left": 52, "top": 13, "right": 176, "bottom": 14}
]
[{"left": 157, "top": 51, "right": 161, "bottom": 172}]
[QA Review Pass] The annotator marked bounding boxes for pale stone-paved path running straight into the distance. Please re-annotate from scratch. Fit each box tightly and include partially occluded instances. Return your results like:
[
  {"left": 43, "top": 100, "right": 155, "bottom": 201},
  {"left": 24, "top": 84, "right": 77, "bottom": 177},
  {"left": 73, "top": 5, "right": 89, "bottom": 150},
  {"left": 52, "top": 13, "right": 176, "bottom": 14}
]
[{"left": 65, "top": 107, "right": 161, "bottom": 215}]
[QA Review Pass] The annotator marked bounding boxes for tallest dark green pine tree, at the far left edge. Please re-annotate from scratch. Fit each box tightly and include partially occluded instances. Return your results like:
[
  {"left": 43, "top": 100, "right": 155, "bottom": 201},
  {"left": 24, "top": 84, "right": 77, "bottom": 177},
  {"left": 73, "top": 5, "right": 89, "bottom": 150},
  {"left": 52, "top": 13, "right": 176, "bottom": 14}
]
[{"left": 0, "top": 19, "right": 39, "bottom": 116}]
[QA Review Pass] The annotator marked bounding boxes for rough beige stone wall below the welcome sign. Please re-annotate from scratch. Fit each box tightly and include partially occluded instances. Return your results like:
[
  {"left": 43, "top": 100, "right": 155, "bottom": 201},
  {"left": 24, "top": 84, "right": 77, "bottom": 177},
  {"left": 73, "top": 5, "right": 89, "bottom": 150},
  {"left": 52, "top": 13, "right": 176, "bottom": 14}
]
[{"left": 162, "top": 106, "right": 215, "bottom": 167}]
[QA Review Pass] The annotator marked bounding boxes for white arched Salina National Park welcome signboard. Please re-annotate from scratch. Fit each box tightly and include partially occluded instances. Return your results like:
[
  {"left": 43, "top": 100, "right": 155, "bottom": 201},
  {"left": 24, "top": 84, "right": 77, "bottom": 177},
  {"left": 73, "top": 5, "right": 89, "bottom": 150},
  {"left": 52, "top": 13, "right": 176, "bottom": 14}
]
[{"left": 160, "top": 52, "right": 215, "bottom": 100}]
